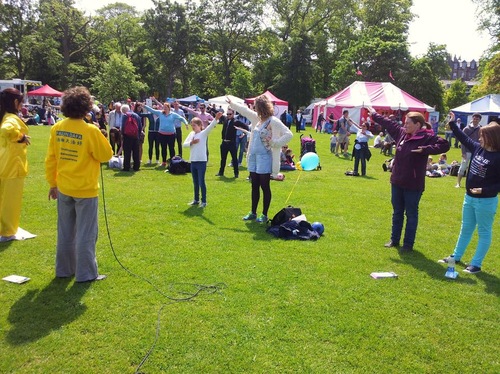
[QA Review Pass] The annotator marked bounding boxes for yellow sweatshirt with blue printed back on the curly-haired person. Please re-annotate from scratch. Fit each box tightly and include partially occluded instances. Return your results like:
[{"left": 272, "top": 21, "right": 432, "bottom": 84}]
[{"left": 45, "top": 118, "right": 113, "bottom": 198}]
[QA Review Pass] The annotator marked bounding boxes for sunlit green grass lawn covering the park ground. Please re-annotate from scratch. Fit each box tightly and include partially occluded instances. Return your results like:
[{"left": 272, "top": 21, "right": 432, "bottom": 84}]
[{"left": 0, "top": 126, "right": 500, "bottom": 373}]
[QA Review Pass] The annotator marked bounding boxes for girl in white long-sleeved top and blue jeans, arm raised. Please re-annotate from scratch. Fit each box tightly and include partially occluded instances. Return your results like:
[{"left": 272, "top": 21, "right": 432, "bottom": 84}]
[{"left": 183, "top": 112, "right": 222, "bottom": 208}]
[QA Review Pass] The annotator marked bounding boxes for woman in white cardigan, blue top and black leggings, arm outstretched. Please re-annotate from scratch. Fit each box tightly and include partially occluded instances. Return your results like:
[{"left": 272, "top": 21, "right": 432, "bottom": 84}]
[{"left": 226, "top": 95, "right": 293, "bottom": 223}]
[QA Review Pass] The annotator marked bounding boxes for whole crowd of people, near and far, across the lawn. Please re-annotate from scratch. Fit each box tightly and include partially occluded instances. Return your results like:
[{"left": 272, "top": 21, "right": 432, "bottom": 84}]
[{"left": 0, "top": 87, "right": 500, "bottom": 282}]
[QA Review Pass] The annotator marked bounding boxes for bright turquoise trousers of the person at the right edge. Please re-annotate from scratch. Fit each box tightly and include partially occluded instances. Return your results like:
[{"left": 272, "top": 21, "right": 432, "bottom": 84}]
[{"left": 453, "top": 195, "right": 498, "bottom": 267}]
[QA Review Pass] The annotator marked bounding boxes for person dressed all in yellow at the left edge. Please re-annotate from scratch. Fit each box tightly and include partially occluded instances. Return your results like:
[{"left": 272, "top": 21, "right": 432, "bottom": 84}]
[{"left": 0, "top": 87, "right": 30, "bottom": 242}]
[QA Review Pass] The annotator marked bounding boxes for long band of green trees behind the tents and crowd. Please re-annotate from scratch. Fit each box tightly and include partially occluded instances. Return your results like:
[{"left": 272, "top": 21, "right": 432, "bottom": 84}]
[{"left": 0, "top": 0, "right": 499, "bottom": 110}]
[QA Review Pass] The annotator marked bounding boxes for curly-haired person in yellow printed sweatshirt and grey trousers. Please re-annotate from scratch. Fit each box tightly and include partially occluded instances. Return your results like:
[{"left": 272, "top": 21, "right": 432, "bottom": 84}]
[{"left": 45, "top": 87, "right": 113, "bottom": 282}]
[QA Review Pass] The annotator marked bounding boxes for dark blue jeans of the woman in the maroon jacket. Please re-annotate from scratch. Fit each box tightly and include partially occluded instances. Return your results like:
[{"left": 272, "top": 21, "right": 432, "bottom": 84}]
[{"left": 391, "top": 184, "right": 423, "bottom": 247}]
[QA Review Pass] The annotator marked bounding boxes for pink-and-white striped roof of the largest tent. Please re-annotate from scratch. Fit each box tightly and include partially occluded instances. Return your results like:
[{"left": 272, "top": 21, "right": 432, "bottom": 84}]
[{"left": 313, "top": 82, "right": 435, "bottom": 128}]
